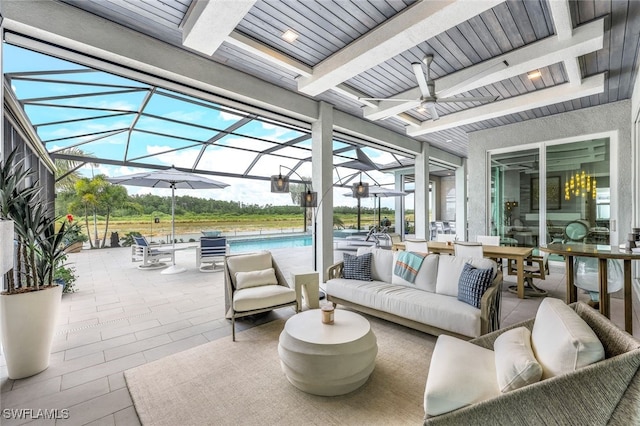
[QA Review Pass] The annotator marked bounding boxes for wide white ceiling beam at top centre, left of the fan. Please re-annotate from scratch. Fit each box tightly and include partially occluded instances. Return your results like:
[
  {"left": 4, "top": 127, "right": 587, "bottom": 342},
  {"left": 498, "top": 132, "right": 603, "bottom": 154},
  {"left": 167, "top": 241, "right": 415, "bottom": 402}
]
[{"left": 298, "top": 0, "right": 503, "bottom": 96}]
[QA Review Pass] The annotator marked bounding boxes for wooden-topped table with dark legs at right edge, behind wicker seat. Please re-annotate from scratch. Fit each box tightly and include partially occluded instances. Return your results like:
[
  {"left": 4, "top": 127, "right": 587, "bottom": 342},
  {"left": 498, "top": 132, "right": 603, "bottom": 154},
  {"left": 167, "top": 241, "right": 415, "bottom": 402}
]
[{"left": 540, "top": 244, "right": 640, "bottom": 334}]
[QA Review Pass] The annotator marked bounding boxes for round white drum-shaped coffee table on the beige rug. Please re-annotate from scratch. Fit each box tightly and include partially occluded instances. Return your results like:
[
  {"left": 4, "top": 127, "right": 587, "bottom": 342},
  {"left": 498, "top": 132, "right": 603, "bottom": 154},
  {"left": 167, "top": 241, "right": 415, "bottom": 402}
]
[{"left": 278, "top": 309, "right": 378, "bottom": 396}]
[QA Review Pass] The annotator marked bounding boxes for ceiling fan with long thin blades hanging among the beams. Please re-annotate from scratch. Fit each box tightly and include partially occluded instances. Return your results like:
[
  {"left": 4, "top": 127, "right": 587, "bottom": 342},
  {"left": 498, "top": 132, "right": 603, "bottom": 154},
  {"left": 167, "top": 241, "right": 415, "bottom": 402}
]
[{"left": 360, "top": 54, "right": 498, "bottom": 121}]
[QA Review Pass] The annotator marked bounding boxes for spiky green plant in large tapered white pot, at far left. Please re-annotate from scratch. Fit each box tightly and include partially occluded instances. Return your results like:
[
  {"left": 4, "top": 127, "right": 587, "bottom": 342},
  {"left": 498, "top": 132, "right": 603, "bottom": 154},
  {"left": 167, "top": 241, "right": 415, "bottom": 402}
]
[{"left": 0, "top": 151, "right": 72, "bottom": 379}]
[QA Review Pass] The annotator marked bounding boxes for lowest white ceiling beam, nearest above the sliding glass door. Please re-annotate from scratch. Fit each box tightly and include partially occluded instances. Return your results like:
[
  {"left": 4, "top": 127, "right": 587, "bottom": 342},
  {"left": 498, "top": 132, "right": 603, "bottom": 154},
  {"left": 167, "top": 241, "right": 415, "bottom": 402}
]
[{"left": 407, "top": 73, "right": 604, "bottom": 137}]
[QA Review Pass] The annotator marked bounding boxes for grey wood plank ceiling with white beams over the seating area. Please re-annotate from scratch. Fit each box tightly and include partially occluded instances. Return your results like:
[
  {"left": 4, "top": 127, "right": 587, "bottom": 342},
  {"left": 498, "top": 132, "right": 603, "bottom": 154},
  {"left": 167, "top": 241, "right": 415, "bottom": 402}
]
[{"left": 56, "top": 0, "right": 640, "bottom": 157}]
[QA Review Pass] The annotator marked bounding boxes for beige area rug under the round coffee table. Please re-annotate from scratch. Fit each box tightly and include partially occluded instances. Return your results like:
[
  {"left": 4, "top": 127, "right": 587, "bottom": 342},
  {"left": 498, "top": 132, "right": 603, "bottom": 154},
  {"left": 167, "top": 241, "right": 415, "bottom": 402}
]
[{"left": 125, "top": 317, "right": 436, "bottom": 426}]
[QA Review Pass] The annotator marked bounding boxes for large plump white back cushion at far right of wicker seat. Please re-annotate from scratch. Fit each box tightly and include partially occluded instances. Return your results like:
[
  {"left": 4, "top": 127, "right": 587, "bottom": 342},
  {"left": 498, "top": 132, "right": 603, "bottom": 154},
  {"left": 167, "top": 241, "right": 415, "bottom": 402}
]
[{"left": 531, "top": 297, "right": 604, "bottom": 379}]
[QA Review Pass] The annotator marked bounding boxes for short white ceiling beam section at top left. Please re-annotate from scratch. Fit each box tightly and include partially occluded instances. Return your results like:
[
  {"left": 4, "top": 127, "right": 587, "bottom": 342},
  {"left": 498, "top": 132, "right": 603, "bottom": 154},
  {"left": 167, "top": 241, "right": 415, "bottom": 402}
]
[{"left": 182, "top": 0, "right": 256, "bottom": 56}]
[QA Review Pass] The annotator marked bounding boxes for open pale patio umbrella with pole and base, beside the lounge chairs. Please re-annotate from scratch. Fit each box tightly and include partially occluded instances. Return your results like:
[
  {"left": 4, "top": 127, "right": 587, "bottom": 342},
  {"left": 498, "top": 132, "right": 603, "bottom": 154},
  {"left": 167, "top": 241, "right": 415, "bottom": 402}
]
[{"left": 107, "top": 166, "right": 229, "bottom": 274}]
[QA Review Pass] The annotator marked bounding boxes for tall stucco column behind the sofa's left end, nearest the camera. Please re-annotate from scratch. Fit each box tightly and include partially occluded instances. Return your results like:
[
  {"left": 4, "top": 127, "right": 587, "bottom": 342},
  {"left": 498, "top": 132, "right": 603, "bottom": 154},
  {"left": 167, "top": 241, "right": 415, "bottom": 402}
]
[{"left": 311, "top": 101, "right": 333, "bottom": 282}]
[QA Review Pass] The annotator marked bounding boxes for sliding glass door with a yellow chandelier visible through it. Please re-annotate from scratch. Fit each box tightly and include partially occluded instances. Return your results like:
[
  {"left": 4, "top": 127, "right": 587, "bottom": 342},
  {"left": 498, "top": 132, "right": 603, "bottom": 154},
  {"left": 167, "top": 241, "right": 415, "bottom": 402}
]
[{"left": 489, "top": 138, "right": 611, "bottom": 247}]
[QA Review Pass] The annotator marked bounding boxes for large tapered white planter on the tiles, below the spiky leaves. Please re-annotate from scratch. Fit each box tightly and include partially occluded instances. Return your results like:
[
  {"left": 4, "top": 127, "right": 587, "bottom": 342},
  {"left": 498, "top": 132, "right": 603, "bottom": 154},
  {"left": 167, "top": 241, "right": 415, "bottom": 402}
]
[{"left": 0, "top": 285, "right": 62, "bottom": 379}]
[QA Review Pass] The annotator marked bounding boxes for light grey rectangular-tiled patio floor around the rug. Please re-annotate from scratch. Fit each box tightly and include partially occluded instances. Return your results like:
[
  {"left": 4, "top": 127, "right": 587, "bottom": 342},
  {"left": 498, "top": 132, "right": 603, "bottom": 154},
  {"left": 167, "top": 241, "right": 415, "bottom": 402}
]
[{"left": 0, "top": 247, "right": 638, "bottom": 425}]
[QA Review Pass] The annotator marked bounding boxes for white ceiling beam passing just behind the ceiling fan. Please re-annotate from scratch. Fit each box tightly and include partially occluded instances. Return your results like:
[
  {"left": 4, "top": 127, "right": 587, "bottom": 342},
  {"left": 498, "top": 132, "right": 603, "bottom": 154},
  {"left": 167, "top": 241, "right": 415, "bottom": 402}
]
[{"left": 364, "top": 19, "right": 604, "bottom": 120}]
